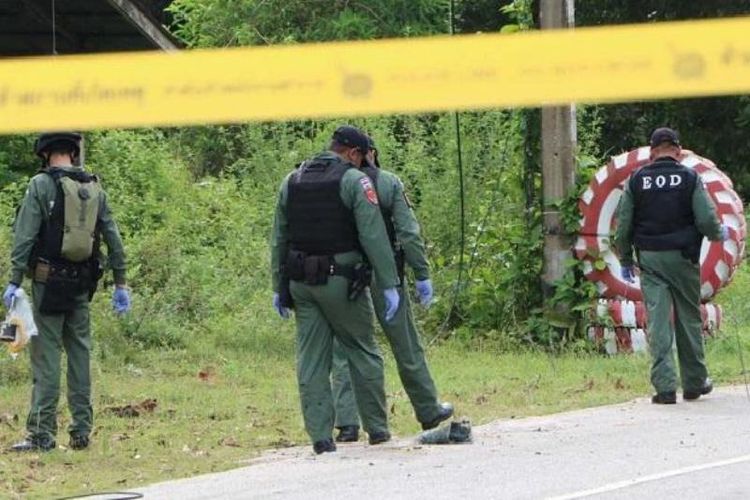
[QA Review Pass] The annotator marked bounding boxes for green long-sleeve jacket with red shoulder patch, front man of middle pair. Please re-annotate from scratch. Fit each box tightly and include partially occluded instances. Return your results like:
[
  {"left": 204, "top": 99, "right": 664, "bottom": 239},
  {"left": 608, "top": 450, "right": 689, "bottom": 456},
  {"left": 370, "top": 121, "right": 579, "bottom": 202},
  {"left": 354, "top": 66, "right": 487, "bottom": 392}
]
[{"left": 271, "top": 151, "right": 399, "bottom": 292}]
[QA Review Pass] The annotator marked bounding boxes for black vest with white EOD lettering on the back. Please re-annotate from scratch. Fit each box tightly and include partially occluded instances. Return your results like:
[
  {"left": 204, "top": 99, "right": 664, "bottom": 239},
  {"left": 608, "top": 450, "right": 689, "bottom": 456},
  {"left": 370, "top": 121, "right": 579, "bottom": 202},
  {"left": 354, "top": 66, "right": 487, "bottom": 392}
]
[{"left": 630, "top": 157, "right": 701, "bottom": 250}]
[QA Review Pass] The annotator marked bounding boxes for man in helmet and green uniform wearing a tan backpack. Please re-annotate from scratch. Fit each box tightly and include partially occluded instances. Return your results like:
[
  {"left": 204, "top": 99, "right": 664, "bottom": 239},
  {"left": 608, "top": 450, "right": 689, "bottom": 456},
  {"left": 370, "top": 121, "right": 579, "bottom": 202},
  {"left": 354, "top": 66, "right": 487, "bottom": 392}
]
[{"left": 3, "top": 133, "right": 130, "bottom": 451}]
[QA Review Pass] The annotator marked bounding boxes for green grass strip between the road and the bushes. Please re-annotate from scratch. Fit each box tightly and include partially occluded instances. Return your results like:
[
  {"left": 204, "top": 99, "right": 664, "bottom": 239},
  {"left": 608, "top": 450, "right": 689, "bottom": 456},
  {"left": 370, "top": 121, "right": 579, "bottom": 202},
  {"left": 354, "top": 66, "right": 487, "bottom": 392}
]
[{"left": 0, "top": 273, "right": 750, "bottom": 498}]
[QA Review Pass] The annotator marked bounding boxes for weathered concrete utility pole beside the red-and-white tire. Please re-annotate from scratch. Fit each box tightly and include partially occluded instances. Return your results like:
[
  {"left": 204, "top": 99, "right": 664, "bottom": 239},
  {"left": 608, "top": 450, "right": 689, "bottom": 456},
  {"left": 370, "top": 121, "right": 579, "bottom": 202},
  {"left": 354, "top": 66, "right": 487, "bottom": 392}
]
[{"left": 540, "top": 0, "right": 576, "bottom": 297}]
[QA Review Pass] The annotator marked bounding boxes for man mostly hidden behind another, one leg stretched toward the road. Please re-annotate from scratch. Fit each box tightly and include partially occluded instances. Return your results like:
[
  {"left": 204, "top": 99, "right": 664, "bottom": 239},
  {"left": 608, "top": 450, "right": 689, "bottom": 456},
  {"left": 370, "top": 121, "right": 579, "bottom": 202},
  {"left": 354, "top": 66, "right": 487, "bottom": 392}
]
[{"left": 332, "top": 139, "right": 453, "bottom": 442}]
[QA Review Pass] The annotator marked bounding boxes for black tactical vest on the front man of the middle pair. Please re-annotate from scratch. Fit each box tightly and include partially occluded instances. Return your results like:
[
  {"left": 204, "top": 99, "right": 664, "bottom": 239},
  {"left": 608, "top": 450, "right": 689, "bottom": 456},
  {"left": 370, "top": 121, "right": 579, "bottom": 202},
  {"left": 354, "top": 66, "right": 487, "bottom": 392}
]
[{"left": 286, "top": 158, "right": 360, "bottom": 255}]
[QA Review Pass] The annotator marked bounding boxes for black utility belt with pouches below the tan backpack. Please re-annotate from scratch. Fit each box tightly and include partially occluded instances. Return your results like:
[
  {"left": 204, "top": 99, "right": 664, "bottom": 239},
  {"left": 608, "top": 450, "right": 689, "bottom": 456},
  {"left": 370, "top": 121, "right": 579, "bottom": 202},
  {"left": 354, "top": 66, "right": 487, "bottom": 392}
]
[{"left": 32, "top": 258, "right": 102, "bottom": 314}]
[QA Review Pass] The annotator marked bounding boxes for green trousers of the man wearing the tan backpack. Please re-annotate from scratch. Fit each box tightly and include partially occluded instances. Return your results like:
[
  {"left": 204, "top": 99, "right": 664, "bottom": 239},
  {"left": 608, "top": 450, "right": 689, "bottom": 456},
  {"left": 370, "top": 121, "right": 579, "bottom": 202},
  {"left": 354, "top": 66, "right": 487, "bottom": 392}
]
[{"left": 26, "top": 282, "right": 94, "bottom": 440}]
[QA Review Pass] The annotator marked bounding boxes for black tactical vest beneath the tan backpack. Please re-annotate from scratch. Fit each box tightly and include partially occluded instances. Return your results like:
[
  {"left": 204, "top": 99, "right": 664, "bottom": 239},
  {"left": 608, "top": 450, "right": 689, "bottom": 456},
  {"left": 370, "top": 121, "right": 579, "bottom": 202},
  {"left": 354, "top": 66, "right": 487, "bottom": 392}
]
[{"left": 29, "top": 168, "right": 101, "bottom": 269}]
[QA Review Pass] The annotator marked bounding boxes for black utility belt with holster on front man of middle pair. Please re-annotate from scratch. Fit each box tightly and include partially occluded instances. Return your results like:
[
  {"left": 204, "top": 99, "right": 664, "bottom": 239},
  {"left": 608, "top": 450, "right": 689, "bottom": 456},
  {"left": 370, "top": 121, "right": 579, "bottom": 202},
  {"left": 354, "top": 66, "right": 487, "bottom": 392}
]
[{"left": 282, "top": 250, "right": 372, "bottom": 300}]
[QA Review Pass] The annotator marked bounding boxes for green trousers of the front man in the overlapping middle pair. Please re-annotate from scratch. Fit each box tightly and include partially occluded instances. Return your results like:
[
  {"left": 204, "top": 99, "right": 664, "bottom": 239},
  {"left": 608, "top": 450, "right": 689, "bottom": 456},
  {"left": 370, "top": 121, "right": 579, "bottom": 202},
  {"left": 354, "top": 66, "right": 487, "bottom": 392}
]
[{"left": 290, "top": 276, "right": 388, "bottom": 442}]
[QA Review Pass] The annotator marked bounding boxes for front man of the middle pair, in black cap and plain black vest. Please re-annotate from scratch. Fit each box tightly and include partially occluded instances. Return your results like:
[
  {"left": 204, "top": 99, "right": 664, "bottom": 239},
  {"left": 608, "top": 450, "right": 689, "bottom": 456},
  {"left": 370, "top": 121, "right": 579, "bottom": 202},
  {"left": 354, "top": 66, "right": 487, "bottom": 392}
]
[{"left": 271, "top": 126, "right": 399, "bottom": 453}]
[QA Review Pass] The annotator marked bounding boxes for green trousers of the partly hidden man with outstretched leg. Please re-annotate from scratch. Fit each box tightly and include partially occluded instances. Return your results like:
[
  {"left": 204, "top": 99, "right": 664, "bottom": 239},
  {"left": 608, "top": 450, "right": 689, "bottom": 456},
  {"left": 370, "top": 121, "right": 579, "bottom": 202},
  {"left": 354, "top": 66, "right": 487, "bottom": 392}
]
[{"left": 332, "top": 287, "right": 440, "bottom": 427}]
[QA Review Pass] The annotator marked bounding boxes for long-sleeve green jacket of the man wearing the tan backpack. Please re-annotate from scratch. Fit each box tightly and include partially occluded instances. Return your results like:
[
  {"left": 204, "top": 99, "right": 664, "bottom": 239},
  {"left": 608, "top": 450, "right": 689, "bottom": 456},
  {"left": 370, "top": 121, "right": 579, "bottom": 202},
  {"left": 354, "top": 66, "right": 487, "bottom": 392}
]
[{"left": 10, "top": 167, "right": 126, "bottom": 285}]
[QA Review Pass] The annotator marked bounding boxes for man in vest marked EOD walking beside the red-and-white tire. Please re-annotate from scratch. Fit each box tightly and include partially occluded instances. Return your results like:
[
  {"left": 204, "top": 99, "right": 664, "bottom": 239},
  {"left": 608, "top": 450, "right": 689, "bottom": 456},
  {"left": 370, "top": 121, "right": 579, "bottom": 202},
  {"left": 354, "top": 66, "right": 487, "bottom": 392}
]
[{"left": 615, "top": 128, "right": 728, "bottom": 404}]
